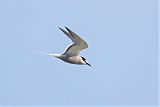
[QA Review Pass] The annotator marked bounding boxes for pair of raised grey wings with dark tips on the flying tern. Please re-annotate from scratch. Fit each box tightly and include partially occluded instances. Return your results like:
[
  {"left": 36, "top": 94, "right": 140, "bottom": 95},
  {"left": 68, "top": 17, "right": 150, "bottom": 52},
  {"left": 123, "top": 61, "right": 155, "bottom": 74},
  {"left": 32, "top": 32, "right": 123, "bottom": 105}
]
[{"left": 60, "top": 27, "right": 88, "bottom": 56}]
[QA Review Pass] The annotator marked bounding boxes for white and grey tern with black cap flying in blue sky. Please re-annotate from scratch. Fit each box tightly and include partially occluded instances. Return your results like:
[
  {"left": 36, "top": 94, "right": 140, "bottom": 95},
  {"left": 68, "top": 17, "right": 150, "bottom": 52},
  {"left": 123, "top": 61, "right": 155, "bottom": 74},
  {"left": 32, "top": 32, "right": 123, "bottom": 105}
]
[{"left": 37, "top": 27, "right": 91, "bottom": 66}]
